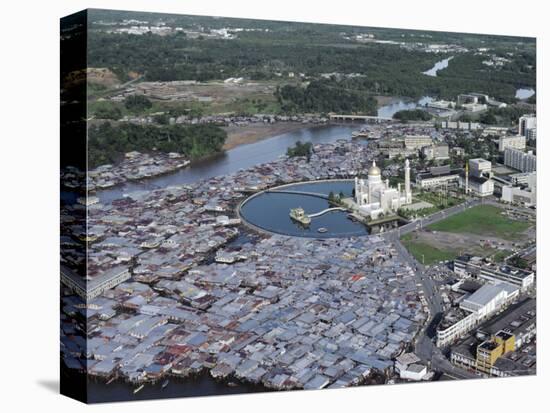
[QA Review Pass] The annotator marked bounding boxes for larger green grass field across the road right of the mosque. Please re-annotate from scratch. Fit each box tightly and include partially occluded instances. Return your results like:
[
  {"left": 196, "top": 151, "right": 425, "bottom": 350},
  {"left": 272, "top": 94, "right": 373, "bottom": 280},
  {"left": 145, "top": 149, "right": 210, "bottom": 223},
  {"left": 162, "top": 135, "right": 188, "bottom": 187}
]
[{"left": 428, "top": 205, "right": 531, "bottom": 241}]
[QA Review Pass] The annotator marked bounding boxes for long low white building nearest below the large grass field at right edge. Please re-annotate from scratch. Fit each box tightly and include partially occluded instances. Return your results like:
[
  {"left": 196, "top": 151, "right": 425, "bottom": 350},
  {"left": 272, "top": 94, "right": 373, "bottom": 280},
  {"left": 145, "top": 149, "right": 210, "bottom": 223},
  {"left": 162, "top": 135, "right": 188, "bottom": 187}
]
[{"left": 454, "top": 255, "right": 535, "bottom": 290}]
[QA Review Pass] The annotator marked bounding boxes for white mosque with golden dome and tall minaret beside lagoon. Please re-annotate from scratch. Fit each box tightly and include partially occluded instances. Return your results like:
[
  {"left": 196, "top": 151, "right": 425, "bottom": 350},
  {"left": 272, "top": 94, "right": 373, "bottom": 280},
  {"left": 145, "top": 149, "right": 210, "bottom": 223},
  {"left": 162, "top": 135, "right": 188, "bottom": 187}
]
[{"left": 355, "top": 159, "right": 412, "bottom": 219}]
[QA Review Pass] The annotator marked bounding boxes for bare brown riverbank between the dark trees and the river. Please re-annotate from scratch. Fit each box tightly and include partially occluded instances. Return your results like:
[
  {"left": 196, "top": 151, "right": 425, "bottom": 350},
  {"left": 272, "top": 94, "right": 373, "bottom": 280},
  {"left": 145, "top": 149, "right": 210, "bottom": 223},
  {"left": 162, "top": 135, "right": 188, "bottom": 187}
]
[{"left": 223, "top": 122, "right": 322, "bottom": 150}]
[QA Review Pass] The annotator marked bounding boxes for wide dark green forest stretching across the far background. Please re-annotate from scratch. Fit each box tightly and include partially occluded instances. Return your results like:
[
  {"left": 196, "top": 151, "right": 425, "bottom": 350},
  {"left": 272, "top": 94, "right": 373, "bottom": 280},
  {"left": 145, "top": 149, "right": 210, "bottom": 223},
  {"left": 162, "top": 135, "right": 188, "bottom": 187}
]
[{"left": 88, "top": 25, "right": 536, "bottom": 104}]
